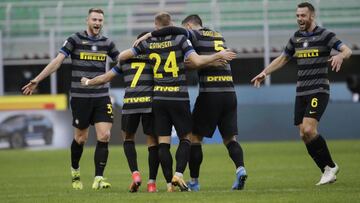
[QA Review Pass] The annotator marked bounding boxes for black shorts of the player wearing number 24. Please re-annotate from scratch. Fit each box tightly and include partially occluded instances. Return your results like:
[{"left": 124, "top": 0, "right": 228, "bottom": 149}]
[{"left": 153, "top": 100, "right": 191, "bottom": 138}]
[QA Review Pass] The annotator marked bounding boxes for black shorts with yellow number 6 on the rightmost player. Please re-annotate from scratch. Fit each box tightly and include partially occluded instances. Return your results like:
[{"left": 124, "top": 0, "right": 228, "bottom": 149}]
[{"left": 294, "top": 93, "right": 329, "bottom": 125}]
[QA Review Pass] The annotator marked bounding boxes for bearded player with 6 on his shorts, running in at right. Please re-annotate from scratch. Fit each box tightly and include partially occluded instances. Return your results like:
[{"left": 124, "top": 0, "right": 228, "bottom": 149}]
[{"left": 251, "top": 2, "right": 351, "bottom": 185}]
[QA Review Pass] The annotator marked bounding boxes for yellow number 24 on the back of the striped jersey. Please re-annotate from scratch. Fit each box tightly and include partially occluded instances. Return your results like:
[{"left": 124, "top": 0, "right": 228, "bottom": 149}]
[{"left": 149, "top": 51, "right": 179, "bottom": 78}]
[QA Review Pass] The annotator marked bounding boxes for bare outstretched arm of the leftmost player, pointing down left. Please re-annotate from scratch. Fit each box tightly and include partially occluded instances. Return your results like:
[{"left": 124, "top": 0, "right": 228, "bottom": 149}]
[{"left": 21, "top": 53, "right": 65, "bottom": 95}]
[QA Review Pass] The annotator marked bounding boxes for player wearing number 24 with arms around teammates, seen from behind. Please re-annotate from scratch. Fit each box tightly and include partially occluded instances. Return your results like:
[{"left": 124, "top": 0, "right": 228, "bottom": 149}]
[{"left": 120, "top": 12, "right": 236, "bottom": 192}]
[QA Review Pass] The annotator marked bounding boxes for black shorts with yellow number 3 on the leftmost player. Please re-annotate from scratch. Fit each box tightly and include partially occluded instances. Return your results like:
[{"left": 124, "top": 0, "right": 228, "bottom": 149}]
[{"left": 70, "top": 97, "right": 114, "bottom": 129}]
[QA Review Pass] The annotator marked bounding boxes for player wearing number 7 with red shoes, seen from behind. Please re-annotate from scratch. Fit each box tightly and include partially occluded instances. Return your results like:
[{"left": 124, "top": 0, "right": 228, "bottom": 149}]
[{"left": 81, "top": 33, "right": 159, "bottom": 192}]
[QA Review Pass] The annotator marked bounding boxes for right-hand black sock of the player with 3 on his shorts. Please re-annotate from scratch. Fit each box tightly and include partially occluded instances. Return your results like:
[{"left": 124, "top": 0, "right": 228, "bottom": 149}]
[{"left": 94, "top": 141, "right": 109, "bottom": 176}]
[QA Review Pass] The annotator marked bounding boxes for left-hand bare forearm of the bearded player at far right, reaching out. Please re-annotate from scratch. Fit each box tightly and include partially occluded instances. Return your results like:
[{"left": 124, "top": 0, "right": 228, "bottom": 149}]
[{"left": 251, "top": 54, "right": 290, "bottom": 88}]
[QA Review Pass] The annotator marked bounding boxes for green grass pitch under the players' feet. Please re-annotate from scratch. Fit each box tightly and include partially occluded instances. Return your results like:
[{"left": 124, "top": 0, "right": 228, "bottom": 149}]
[{"left": 0, "top": 140, "right": 360, "bottom": 203}]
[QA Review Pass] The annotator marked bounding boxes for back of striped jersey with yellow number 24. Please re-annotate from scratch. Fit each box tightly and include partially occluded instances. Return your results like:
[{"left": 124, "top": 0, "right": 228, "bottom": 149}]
[{"left": 134, "top": 35, "right": 194, "bottom": 101}]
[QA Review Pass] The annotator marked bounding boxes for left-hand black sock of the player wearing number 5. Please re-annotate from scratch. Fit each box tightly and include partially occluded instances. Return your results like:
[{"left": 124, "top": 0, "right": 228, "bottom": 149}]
[{"left": 189, "top": 143, "right": 203, "bottom": 178}]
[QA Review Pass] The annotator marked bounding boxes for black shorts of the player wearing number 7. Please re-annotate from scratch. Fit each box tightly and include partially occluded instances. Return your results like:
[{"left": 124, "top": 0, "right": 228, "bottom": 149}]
[{"left": 121, "top": 113, "right": 154, "bottom": 135}]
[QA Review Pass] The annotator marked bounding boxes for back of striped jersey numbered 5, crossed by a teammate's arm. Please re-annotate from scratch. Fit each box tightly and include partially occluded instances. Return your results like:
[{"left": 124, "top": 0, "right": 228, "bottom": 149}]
[{"left": 190, "top": 28, "right": 235, "bottom": 92}]
